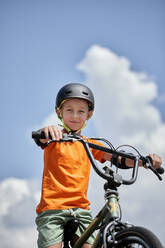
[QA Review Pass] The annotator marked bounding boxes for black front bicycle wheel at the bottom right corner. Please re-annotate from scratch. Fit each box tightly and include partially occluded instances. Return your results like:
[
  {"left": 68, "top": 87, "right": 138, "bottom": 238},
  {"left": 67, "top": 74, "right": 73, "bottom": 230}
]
[{"left": 109, "top": 226, "right": 163, "bottom": 248}]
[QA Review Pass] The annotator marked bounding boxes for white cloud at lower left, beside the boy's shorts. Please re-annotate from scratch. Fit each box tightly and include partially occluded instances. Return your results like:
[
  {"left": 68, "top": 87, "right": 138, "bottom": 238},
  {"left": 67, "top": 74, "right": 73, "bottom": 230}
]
[{"left": 0, "top": 178, "right": 40, "bottom": 248}]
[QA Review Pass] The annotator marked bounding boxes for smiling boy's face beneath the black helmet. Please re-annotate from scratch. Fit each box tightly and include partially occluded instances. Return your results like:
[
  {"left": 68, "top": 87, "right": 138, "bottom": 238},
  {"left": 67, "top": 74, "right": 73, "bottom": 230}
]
[{"left": 61, "top": 98, "right": 90, "bottom": 131}]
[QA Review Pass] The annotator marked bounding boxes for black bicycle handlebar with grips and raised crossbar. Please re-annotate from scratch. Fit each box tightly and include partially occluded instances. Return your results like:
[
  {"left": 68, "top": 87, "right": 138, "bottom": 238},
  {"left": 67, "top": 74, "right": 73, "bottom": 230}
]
[{"left": 32, "top": 130, "right": 164, "bottom": 185}]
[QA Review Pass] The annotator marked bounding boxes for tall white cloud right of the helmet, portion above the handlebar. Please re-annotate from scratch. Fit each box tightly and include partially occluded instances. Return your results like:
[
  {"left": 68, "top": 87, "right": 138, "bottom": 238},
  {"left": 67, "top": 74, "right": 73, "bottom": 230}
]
[{"left": 78, "top": 46, "right": 165, "bottom": 155}]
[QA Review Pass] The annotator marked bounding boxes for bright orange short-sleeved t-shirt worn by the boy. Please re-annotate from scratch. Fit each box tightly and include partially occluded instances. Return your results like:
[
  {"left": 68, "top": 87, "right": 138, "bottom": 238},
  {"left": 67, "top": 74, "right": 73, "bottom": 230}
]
[{"left": 36, "top": 139, "right": 104, "bottom": 213}]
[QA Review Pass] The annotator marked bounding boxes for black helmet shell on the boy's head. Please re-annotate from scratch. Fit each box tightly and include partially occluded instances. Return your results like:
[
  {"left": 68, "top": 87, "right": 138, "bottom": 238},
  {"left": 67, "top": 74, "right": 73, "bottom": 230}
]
[{"left": 55, "top": 83, "right": 94, "bottom": 111}]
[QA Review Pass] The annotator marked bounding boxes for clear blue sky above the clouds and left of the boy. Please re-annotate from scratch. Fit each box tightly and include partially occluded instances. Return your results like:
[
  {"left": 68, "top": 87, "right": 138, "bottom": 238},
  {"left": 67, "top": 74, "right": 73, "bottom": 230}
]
[{"left": 0, "top": 0, "right": 165, "bottom": 247}]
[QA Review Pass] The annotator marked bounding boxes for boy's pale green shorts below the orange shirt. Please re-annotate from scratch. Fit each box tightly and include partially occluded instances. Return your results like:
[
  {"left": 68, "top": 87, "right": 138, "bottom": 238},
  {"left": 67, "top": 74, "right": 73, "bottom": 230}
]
[{"left": 36, "top": 208, "right": 95, "bottom": 248}]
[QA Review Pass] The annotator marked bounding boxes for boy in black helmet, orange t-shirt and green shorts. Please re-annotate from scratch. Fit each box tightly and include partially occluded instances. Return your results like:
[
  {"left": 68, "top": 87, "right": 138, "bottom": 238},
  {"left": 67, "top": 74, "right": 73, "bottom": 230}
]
[{"left": 36, "top": 84, "right": 161, "bottom": 248}]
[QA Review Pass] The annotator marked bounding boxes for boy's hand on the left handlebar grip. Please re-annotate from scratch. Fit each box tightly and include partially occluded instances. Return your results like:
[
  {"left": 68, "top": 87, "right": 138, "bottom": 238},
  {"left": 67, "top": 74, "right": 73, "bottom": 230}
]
[{"left": 40, "top": 126, "right": 62, "bottom": 144}]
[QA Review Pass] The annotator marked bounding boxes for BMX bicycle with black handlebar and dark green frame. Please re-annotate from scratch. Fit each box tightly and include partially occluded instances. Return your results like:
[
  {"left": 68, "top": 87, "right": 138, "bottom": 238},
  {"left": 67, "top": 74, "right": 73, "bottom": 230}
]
[{"left": 32, "top": 131, "right": 164, "bottom": 248}]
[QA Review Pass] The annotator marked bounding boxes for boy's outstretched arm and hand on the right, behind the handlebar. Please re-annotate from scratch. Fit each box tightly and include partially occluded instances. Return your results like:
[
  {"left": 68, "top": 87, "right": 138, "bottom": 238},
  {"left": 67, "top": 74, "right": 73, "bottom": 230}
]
[{"left": 103, "top": 153, "right": 162, "bottom": 169}]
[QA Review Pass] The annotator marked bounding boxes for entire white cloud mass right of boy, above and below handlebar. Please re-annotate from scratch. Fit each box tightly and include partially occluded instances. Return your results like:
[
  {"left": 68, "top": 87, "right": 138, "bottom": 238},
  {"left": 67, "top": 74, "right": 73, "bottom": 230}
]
[{"left": 77, "top": 45, "right": 165, "bottom": 243}]
